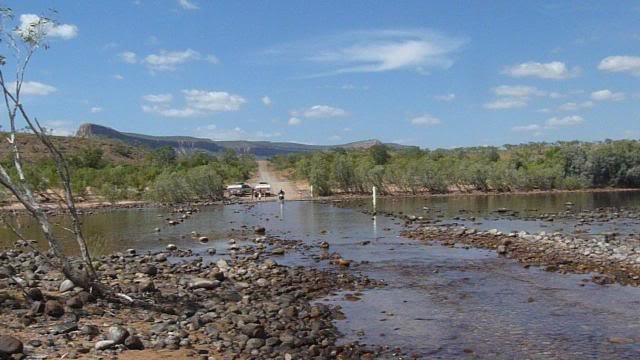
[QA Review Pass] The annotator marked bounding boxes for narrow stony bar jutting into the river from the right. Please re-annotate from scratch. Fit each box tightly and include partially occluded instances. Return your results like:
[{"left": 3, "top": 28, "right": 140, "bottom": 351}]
[{"left": 403, "top": 217, "right": 640, "bottom": 286}]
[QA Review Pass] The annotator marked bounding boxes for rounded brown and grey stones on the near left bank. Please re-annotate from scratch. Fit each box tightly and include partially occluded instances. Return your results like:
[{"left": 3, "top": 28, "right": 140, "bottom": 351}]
[{"left": 0, "top": 228, "right": 389, "bottom": 359}]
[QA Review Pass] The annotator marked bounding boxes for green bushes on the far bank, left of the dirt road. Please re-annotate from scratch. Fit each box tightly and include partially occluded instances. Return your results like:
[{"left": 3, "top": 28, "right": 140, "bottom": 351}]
[{"left": 0, "top": 146, "right": 257, "bottom": 203}]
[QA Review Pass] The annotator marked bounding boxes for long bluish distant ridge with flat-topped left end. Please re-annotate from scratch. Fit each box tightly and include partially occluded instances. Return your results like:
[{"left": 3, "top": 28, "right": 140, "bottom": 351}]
[{"left": 76, "top": 123, "right": 411, "bottom": 157}]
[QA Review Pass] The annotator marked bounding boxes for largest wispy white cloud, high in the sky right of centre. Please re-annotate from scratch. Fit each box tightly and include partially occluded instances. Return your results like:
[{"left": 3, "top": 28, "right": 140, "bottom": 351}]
[{"left": 269, "top": 29, "right": 465, "bottom": 76}]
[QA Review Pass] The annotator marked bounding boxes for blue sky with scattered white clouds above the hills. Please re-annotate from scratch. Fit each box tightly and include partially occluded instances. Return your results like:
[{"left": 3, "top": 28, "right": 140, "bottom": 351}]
[{"left": 2, "top": 0, "right": 640, "bottom": 148}]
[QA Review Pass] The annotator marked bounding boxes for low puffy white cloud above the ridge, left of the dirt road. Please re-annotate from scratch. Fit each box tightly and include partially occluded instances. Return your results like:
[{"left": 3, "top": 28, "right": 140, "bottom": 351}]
[{"left": 142, "top": 89, "right": 246, "bottom": 118}]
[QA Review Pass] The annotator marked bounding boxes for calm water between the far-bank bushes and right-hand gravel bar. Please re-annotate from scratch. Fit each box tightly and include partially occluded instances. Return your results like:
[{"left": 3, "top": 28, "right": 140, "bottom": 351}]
[{"left": 345, "top": 190, "right": 640, "bottom": 238}]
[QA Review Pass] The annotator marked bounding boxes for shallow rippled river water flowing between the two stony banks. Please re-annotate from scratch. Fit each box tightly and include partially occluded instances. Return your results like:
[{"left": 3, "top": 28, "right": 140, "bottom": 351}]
[{"left": 0, "top": 194, "right": 640, "bottom": 359}]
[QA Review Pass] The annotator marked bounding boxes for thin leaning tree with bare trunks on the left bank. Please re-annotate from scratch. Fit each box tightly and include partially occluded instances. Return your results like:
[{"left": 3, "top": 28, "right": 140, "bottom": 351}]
[{"left": 0, "top": 8, "right": 102, "bottom": 293}]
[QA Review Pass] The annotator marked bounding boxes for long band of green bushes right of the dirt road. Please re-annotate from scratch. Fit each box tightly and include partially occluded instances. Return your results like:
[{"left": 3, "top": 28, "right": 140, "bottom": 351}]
[{"left": 271, "top": 140, "right": 640, "bottom": 196}]
